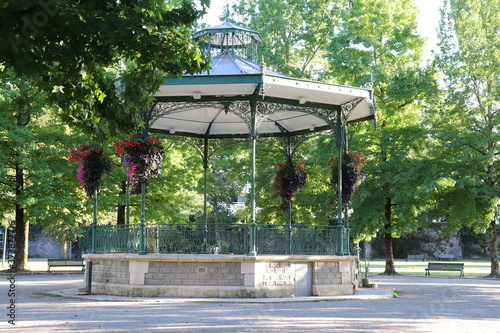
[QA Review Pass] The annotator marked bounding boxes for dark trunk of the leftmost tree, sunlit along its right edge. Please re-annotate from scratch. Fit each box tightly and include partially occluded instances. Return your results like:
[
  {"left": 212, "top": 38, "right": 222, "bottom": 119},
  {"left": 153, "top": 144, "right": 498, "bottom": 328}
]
[{"left": 12, "top": 166, "right": 29, "bottom": 272}]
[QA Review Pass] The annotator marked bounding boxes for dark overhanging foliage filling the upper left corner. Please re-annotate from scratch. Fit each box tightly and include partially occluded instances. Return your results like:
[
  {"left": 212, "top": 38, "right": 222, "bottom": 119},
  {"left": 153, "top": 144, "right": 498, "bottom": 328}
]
[{"left": 0, "top": 0, "right": 209, "bottom": 133}]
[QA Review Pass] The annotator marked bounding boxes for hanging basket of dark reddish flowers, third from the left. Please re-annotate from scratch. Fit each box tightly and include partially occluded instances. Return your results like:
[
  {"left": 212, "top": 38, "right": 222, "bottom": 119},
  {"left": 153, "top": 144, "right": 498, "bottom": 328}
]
[{"left": 274, "top": 161, "right": 307, "bottom": 211}]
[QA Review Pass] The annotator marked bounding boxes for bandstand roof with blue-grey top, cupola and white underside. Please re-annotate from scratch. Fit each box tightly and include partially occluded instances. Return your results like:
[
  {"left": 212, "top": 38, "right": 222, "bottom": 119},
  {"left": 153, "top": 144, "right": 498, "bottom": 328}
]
[{"left": 149, "top": 22, "right": 375, "bottom": 138}]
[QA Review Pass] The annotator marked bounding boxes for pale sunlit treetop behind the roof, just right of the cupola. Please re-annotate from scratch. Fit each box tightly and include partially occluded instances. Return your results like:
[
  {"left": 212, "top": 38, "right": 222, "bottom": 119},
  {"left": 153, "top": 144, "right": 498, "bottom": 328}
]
[{"left": 233, "top": 0, "right": 338, "bottom": 78}]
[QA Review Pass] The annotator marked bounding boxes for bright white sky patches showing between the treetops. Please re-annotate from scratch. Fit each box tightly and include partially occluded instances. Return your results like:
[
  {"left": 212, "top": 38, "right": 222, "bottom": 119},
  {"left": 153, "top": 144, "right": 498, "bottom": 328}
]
[{"left": 202, "top": 0, "right": 443, "bottom": 53}]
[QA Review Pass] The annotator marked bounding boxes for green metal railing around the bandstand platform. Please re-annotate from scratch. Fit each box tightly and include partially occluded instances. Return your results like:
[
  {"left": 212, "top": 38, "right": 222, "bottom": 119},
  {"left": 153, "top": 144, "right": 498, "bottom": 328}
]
[{"left": 79, "top": 223, "right": 347, "bottom": 255}]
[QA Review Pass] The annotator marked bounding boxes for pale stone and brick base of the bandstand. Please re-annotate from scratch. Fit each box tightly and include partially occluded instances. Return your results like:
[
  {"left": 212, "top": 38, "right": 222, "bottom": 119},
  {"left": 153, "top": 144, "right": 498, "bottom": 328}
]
[{"left": 83, "top": 254, "right": 358, "bottom": 298}]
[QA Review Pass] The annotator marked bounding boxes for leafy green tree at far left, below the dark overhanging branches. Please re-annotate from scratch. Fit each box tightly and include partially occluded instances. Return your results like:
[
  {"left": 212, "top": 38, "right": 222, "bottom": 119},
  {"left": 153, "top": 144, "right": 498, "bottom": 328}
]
[{"left": 0, "top": 73, "right": 89, "bottom": 271}]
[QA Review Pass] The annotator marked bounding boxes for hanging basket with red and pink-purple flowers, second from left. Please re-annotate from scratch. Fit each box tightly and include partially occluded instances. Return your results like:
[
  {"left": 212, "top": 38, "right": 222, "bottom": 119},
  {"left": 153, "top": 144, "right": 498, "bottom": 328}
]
[{"left": 114, "top": 135, "right": 165, "bottom": 194}]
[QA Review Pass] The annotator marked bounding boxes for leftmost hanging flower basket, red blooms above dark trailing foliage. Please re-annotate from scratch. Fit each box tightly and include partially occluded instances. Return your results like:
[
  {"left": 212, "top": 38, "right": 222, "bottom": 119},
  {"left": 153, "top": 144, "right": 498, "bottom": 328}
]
[{"left": 68, "top": 145, "right": 113, "bottom": 198}]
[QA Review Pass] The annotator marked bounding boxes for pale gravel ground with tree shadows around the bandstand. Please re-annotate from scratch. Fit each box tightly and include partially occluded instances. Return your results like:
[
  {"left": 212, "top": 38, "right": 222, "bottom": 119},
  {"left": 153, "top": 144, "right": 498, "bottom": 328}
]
[{"left": 0, "top": 273, "right": 500, "bottom": 333}]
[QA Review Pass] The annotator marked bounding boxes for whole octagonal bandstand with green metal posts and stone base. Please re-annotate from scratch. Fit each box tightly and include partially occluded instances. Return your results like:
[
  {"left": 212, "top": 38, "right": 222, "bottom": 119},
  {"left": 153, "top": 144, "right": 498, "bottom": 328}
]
[{"left": 84, "top": 22, "right": 375, "bottom": 298}]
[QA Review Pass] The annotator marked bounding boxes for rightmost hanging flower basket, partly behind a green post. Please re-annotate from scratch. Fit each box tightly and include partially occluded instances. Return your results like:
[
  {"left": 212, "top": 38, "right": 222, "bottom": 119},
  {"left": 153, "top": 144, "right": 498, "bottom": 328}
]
[{"left": 330, "top": 153, "right": 366, "bottom": 206}]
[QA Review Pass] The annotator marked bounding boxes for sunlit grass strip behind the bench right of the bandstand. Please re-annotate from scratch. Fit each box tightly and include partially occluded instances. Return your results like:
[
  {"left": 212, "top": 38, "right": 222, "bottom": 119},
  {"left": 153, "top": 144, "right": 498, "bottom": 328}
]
[{"left": 360, "top": 259, "right": 491, "bottom": 277}]
